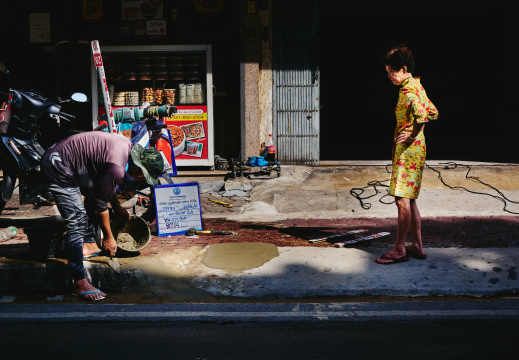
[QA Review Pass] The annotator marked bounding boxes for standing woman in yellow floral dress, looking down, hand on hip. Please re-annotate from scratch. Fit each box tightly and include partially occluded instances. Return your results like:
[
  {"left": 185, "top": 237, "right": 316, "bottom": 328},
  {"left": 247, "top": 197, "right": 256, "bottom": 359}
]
[{"left": 376, "top": 45, "right": 438, "bottom": 264}]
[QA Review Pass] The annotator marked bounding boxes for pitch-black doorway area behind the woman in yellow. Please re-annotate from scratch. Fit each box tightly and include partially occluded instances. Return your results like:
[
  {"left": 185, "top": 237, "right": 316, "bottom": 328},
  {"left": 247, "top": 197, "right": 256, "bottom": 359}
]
[{"left": 320, "top": 1, "right": 519, "bottom": 161}]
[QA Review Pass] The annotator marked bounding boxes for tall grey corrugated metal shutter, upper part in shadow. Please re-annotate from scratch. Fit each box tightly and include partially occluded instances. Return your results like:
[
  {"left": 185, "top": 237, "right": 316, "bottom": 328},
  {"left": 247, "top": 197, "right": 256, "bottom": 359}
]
[{"left": 272, "top": 0, "right": 319, "bottom": 165}]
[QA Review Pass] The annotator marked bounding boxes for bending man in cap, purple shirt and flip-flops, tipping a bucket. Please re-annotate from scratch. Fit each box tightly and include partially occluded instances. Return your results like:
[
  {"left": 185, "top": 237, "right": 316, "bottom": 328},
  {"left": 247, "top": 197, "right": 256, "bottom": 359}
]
[{"left": 41, "top": 131, "right": 164, "bottom": 300}]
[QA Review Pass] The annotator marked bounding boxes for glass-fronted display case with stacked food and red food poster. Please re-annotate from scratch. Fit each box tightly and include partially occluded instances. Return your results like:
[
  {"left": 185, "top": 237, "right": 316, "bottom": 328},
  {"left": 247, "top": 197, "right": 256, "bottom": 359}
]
[{"left": 92, "top": 45, "right": 214, "bottom": 167}]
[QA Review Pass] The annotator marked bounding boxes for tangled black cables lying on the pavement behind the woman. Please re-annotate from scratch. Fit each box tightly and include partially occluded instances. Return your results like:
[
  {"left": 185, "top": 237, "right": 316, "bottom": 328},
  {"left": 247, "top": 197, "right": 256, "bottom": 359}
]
[{"left": 350, "top": 161, "right": 519, "bottom": 215}]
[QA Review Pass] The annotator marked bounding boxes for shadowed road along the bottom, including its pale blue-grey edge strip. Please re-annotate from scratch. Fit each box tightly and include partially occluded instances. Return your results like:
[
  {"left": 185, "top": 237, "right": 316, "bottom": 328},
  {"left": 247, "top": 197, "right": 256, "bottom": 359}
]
[{"left": 0, "top": 300, "right": 519, "bottom": 359}]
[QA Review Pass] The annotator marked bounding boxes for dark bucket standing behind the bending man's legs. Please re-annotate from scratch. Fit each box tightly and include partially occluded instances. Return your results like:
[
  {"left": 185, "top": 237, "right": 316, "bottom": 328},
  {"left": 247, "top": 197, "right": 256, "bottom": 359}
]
[{"left": 23, "top": 224, "right": 65, "bottom": 259}]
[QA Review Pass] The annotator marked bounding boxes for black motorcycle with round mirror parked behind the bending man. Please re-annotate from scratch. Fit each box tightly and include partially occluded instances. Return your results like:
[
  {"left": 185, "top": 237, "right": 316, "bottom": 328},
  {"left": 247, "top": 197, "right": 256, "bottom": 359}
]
[{"left": 0, "top": 63, "right": 88, "bottom": 213}]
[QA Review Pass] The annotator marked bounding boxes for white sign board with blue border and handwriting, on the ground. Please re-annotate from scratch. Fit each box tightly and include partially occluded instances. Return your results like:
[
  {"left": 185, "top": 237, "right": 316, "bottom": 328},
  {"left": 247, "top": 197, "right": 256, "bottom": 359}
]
[{"left": 154, "top": 183, "right": 203, "bottom": 236}]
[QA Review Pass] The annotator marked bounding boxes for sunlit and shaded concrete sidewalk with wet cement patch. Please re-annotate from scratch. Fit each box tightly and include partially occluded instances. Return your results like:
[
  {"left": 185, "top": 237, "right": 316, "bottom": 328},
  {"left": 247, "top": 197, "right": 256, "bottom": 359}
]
[{"left": 0, "top": 162, "right": 519, "bottom": 301}]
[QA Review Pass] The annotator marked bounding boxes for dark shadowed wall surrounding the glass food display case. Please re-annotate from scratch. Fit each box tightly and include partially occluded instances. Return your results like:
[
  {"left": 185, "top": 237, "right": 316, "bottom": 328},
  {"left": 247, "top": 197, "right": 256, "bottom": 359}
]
[{"left": 0, "top": 0, "right": 240, "bottom": 157}]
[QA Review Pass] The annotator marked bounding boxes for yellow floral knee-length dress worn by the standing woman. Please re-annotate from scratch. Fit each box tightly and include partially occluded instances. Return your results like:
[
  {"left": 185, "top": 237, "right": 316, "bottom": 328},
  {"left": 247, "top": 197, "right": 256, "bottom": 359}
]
[{"left": 388, "top": 78, "right": 438, "bottom": 199}]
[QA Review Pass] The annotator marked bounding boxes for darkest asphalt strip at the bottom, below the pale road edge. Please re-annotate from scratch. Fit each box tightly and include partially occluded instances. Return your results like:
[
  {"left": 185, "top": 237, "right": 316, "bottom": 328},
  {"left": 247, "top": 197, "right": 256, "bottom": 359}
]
[{"left": 0, "top": 320, "right": 519, "bottom": 360}]
